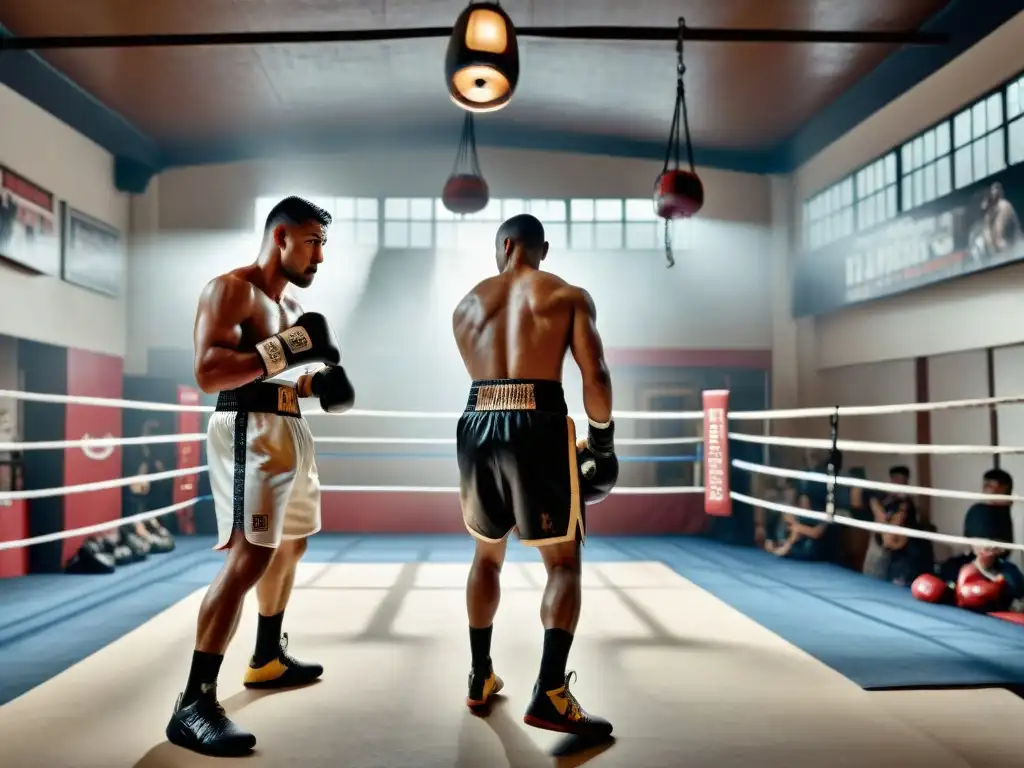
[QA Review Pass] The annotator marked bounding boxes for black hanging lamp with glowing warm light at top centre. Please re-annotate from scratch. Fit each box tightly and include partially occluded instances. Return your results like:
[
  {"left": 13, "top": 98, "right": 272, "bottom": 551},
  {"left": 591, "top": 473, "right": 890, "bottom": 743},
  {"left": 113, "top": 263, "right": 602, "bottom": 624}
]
[{"left": 444, "top": 2, "right": 519, "bottom": 112}]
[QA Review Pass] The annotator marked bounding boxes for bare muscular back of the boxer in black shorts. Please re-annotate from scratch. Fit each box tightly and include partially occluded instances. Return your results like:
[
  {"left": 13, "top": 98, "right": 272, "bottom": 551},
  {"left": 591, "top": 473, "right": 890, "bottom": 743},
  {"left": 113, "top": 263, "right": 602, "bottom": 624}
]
[{"left": 453, "top": 268, "right": 608, "bottom": 415}]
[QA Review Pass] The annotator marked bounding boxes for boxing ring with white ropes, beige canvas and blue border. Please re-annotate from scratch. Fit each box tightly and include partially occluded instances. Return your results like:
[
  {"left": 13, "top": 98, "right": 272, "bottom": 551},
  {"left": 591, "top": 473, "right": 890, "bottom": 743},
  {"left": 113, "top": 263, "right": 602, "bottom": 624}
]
[{"left": 0, "top": 391, "right": 1024, "bottom": 768}]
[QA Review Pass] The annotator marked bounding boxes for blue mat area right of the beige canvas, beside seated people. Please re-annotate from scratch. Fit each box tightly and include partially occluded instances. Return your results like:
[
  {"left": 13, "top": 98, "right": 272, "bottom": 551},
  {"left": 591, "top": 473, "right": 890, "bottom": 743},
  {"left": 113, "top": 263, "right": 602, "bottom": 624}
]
[{"left": 614, "top": 538, "right": 1024, "bottom": 690}]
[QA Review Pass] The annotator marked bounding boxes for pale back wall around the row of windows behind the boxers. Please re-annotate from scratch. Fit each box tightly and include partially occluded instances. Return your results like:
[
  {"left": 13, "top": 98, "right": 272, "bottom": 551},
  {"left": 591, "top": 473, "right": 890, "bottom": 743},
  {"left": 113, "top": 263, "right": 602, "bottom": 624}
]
[{"left": 128, "top": 151, "right": 771, "bottom": 373}]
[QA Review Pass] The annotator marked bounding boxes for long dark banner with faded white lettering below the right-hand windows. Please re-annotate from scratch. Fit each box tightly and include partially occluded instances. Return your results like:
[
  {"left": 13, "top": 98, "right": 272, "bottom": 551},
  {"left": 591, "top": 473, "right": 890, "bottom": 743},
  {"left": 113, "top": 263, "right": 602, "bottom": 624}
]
[{"left": 793, "top": 160, "right": 1024, "bottom": 317}]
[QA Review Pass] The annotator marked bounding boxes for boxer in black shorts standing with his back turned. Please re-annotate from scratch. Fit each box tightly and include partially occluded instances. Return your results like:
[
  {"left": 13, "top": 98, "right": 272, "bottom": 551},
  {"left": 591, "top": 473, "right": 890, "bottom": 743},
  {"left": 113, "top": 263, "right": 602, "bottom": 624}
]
[{"left": 453, "top": 214, "right": 618, "bottom": 736}]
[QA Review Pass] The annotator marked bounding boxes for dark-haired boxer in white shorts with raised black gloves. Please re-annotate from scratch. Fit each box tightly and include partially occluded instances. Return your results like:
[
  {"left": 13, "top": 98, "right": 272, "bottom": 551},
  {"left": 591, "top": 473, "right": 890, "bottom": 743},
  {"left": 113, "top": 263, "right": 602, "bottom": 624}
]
[{"left": 167, "top": 198, "right": 354, "bottom": 757}]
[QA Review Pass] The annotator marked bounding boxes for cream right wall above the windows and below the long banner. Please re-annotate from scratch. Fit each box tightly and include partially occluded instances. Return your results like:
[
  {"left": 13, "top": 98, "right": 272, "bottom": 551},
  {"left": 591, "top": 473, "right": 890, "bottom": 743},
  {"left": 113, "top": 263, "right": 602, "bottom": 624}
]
[{"left": 796, "top": 12, "right": 1024, "bottom": 368}]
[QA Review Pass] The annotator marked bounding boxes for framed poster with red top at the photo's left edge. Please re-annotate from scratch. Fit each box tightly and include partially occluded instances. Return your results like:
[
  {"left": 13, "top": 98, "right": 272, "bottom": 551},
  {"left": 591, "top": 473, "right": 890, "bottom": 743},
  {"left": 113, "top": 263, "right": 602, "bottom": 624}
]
[{"left": 0, "top": 166, "right": 60, "bottom": 276}]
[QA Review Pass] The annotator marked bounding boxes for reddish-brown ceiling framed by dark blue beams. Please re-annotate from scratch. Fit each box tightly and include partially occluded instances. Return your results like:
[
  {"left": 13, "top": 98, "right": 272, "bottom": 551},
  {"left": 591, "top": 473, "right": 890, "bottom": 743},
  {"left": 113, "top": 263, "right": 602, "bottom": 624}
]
[{"left": 0, "top": 0, "right": 1022, "bottom": 191}]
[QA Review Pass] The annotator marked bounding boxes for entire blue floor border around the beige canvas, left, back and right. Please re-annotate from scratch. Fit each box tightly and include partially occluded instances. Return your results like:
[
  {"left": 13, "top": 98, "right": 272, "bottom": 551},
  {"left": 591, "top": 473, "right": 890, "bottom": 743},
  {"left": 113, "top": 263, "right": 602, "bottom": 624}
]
[{"left": 0, "top": 535, "right": 1024, "bottom": 703}]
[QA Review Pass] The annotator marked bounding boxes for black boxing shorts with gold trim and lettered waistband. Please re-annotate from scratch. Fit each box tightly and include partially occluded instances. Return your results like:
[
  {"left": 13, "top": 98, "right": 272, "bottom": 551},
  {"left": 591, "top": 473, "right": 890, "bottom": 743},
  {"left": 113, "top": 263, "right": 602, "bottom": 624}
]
[{"left": 456, "top": 379, "right": 585, "bottom": 547}]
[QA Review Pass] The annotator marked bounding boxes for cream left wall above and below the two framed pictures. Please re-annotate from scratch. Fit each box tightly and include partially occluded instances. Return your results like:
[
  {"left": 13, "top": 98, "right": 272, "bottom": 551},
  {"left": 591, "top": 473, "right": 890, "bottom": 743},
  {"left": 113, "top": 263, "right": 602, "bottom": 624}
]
[{"left": 0, "top": 85, "right": 129, "bottom": 355}]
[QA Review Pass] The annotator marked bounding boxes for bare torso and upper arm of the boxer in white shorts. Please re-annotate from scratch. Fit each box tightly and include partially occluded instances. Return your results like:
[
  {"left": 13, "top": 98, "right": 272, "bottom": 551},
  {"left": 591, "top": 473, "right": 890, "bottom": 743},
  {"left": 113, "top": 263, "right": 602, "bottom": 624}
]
[{"left": 194, "top": 265, "right": 303, "bottom": 392}]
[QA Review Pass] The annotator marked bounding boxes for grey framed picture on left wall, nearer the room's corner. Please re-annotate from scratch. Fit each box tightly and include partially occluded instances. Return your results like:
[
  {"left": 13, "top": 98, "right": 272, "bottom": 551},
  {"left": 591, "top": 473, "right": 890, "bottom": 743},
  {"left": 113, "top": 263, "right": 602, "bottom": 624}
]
[{"left": 60, "top": 203, "right": 125, "bottom": 298}]
